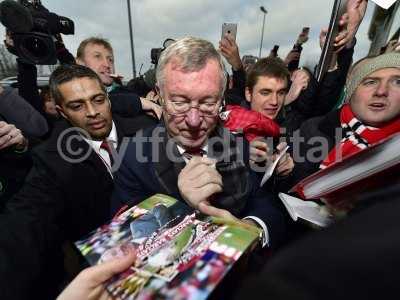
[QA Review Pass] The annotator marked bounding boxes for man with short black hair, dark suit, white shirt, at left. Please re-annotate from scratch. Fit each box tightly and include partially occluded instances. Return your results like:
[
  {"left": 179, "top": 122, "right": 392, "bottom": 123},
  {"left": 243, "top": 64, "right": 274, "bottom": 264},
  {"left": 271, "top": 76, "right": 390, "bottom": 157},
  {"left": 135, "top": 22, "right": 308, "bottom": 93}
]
[{"left": 0, "top": 65, "right": 159, "bottom": 299}]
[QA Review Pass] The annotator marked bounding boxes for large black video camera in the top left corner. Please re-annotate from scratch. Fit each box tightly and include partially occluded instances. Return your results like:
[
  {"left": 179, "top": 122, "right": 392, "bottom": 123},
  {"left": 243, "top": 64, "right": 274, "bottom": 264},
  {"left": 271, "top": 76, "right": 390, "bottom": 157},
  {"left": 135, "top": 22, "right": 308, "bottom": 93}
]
[{"left": 0, "top": 0, "right": 75, "bottom": 65}]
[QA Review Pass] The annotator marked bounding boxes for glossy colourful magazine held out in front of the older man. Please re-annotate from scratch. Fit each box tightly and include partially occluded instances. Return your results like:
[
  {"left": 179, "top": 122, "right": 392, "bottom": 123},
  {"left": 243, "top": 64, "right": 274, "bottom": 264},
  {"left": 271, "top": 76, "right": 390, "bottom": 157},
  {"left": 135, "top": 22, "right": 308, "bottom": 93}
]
[{"left": 75, "top": 194, "right": 258, "bottom": 299}]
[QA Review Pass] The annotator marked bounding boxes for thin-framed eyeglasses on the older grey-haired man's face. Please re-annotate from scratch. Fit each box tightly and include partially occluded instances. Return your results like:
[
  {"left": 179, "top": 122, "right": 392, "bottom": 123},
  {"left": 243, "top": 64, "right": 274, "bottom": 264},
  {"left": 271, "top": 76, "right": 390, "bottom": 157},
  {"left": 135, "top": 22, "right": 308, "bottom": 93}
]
[{"left": 162, "top": 99, "right": 221, "bottom": 117}]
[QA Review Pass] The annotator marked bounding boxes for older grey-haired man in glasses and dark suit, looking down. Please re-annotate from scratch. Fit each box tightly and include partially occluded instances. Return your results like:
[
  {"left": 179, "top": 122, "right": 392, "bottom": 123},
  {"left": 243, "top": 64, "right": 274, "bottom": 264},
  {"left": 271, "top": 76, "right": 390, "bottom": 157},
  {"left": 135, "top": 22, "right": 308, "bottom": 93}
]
[{"left": 113, "top": 38, "right": 285, "bottom": 251}]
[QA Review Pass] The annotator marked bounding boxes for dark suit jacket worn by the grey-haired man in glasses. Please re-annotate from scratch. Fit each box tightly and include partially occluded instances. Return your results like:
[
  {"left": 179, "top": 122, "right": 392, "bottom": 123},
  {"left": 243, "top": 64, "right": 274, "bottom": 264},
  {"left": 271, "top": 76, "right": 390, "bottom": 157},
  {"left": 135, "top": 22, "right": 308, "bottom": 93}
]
[{"left": 112, "top": 124, "right": 285, "bottom": 250}]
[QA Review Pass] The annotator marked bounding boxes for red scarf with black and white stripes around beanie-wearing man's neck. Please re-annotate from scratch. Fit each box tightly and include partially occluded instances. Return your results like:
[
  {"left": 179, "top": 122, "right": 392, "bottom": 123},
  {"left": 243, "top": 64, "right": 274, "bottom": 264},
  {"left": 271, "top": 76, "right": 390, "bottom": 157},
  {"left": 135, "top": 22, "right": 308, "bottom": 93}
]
[{"left": 320, "top": 104, "right": 400, "bottom": 169}]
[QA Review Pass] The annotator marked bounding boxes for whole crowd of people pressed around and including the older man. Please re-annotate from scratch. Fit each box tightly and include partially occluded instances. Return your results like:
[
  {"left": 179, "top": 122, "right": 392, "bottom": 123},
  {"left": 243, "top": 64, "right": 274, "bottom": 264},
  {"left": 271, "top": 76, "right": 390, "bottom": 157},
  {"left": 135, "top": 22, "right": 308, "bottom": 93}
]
[{"left": 0, "top": 0, "right": 400, "bottom": 300}]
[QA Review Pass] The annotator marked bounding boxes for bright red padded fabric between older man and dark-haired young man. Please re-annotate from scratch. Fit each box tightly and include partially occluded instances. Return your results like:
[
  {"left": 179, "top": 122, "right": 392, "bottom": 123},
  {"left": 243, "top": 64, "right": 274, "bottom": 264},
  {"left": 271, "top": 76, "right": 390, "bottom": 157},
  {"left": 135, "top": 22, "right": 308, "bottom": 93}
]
[{"left": 221, "top": 105, "right": 280, "bottom": 142}]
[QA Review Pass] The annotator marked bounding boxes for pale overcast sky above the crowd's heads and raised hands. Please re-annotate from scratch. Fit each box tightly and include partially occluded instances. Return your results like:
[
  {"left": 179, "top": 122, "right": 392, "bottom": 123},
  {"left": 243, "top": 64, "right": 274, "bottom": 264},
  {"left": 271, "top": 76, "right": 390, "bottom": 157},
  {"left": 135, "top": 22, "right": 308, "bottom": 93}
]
[{"left": 3, "top": 0, "right": 394, "bottom": 79}]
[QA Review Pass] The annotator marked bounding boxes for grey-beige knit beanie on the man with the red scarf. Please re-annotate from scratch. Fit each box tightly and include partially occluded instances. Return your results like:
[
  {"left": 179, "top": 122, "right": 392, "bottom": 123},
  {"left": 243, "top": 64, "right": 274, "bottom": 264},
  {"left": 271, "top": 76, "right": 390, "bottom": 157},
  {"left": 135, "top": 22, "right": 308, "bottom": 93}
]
[{"left": 345, "top": 52, "right": 400, "bottom": 102}]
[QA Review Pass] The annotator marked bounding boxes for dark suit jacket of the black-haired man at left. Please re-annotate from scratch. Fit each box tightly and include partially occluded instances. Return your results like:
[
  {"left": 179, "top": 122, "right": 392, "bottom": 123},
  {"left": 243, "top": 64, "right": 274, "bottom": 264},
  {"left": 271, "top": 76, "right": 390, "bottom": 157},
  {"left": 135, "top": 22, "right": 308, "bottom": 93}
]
[{"left": 0, "top": 118, "right": 156, "bottom": 299}]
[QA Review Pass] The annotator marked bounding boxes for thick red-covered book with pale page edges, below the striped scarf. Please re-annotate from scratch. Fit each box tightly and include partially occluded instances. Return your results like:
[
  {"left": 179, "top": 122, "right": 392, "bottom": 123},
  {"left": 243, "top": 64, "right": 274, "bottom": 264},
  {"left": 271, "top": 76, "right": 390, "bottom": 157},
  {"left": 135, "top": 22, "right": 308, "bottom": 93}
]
[{"left": 291, "top": 134, "right": 400, "bottom": 207}]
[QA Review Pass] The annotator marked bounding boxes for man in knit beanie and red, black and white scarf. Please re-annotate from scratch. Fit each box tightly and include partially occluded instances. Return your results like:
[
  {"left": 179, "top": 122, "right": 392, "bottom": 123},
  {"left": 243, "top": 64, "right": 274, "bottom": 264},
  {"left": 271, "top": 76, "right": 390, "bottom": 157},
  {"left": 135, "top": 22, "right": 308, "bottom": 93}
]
[{"left": 290, "top": 52, "right": 400, "bottom": 185}]
